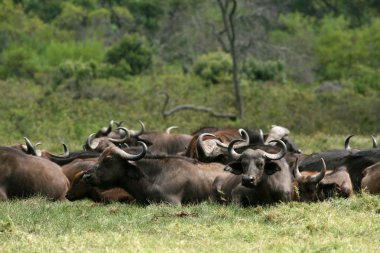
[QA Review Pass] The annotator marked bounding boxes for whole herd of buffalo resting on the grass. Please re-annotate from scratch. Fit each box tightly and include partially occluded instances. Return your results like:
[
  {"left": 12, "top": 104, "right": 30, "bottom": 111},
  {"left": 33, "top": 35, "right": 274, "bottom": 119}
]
[{"left": 0, "top": 120, "right": 380, "bottom": 206}]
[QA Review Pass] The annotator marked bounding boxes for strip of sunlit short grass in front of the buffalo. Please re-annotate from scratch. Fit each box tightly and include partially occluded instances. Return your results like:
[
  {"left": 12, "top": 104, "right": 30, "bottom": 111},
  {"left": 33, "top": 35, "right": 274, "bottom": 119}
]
[{"left": 0, "top": 194, "right": 380, "bottom": 252}]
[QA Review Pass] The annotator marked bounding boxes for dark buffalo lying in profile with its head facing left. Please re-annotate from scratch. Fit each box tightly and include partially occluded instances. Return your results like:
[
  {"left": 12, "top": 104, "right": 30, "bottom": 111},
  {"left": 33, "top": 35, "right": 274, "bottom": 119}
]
[{"left": 83, "top": 142, "right": 226, "bottom": 204}]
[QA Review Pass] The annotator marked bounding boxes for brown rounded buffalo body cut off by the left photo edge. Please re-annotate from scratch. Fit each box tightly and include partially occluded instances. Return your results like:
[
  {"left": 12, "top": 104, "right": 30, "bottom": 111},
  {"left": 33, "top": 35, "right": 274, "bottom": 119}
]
[{"left": 0, "top": 147, "right": 69, "bottom": 200}]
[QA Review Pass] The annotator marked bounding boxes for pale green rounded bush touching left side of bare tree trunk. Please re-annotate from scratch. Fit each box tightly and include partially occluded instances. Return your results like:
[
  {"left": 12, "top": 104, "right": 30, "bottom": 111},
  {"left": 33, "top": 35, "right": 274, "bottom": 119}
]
[{"left": 193, "top": 52, "right": 232, "bottom": 84}]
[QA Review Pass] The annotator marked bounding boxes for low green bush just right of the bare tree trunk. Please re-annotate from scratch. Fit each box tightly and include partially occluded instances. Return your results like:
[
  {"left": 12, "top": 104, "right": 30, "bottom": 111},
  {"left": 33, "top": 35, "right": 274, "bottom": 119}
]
[{"left": 243, "top": 58, "right": 286, "bottom": 82}]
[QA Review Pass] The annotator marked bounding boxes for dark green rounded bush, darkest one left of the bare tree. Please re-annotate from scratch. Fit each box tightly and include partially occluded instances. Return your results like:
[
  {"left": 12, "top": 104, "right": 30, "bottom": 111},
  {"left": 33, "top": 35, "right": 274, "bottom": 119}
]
[{"left": 106, "top": 34, "right": 152, "bottom": 75}]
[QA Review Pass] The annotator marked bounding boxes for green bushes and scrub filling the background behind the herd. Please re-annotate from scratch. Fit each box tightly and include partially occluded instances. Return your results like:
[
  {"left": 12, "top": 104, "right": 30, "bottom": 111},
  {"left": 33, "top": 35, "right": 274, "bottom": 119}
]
[{"left": 0, "top": 0, "right": 380, "bottom": 145}]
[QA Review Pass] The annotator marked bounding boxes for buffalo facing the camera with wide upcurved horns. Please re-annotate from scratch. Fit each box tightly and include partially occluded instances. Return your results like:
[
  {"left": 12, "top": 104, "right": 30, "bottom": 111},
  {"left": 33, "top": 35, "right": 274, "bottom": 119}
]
[{"left": 213, "top": 140, "right": 292, "bottom": 206}]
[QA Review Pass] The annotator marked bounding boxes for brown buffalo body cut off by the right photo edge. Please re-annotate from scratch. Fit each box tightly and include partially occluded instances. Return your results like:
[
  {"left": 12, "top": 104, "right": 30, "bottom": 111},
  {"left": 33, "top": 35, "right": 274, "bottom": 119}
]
[{"left": 361, "top": 162, "right": 380, "bottom": 194}]
